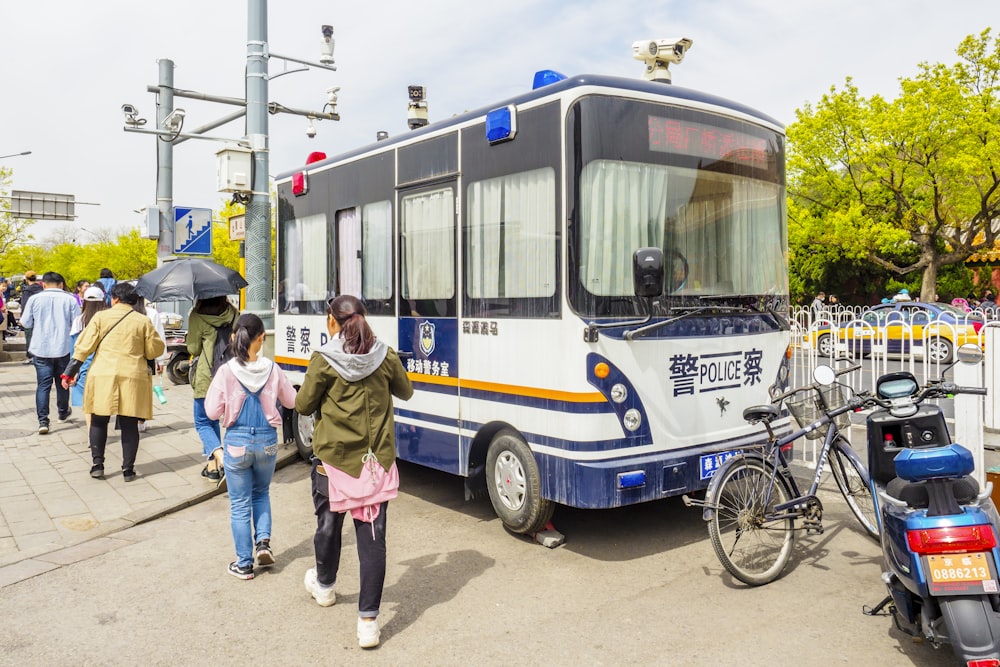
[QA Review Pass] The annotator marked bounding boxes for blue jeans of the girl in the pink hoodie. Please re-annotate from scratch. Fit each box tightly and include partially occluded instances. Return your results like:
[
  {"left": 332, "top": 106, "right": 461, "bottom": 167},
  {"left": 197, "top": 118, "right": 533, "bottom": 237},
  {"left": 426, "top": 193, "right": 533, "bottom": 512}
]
[{"left": 223, "top": 427, "right": 278, "bottom": 567}]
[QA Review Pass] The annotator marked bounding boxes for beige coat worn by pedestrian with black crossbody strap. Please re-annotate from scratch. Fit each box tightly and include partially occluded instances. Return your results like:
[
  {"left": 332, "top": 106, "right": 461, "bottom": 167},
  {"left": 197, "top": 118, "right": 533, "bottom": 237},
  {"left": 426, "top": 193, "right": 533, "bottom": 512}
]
[{"left": 73, "top": 303, "right": 164, "bottom": 419}]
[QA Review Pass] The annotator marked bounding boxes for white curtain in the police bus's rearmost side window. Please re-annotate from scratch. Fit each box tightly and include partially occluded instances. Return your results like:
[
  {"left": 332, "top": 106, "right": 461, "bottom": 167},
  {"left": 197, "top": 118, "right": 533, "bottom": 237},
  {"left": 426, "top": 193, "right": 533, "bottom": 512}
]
[{"left": 278, "top": 213, "right": 330, "bottom": 313}]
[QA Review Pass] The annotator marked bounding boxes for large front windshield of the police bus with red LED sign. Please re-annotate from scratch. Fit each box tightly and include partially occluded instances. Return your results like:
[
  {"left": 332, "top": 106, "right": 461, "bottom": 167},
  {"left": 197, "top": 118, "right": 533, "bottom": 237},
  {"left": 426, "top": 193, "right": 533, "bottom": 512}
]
[{"left": 570, "top": 99, "right": 788, "bottom": 317}]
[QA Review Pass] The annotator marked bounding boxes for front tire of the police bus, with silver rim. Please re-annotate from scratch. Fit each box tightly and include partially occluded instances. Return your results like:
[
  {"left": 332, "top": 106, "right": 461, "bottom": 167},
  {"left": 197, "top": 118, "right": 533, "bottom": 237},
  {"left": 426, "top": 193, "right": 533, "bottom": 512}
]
[{"left": 486, "top": 429, "right": 555, "bottom": 535}]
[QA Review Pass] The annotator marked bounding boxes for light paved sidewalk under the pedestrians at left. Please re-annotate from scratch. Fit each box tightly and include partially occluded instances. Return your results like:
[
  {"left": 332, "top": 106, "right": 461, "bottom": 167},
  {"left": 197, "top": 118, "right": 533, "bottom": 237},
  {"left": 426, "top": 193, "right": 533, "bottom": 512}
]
[{"left": 0, "top": 362, "right": 297, "bottom": 588}]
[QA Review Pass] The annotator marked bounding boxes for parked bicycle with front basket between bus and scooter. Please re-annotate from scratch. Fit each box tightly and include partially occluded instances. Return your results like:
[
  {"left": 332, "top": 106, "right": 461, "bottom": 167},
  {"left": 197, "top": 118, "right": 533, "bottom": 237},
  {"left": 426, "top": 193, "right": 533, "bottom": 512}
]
[{"left": 684, "top": 365, "right": 879, "bottom": 586}]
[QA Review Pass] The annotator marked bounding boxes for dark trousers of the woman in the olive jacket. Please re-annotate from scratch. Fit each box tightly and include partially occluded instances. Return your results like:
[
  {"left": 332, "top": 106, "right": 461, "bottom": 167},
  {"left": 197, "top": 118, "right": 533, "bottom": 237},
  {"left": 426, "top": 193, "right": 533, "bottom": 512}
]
[{"left": 312, "top": 459, "right": 389, "bottom": 618}]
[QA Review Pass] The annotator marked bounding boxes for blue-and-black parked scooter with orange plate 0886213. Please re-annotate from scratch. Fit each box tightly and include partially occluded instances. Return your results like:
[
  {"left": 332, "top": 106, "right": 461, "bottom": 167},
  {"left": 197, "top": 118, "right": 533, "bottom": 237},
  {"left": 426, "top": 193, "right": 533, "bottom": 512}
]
[{"left": 867, "top": 346, "right": 1000, "bottom": 667}]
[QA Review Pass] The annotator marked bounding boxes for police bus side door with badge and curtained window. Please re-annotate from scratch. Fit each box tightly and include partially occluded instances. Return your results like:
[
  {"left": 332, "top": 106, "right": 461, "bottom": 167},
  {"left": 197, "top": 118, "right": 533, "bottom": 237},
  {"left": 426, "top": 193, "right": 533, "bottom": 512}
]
[{"left": 396, "top": 179, "right": 464, "bottom": 474}]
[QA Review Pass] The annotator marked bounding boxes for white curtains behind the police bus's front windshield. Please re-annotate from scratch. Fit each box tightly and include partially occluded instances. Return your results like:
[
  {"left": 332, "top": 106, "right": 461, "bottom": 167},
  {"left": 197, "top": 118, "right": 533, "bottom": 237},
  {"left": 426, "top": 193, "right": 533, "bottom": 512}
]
[{"left": 580, "top": 160, "right": 787, "bottom": 296}]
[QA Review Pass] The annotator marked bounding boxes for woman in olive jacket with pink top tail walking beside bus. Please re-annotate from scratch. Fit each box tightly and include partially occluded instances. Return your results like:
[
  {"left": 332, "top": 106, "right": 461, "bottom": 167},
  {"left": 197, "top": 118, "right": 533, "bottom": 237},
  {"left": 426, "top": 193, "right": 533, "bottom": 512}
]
[{"left": 295, "top": 295, "right": 413, "bottom": 648}]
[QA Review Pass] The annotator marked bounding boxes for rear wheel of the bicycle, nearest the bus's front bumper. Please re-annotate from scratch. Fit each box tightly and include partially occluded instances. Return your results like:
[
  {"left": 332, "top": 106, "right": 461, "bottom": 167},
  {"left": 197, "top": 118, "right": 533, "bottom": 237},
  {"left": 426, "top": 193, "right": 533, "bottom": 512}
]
[{"left": 707, "top": 457, "right": 795, "bottom": 586}]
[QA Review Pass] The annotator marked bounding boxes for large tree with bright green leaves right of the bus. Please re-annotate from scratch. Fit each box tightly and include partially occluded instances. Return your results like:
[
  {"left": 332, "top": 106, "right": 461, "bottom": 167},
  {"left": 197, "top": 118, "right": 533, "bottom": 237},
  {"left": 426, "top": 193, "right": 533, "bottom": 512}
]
[{"left": 788, "top": 29, "right": 1000, "bottom": 301}]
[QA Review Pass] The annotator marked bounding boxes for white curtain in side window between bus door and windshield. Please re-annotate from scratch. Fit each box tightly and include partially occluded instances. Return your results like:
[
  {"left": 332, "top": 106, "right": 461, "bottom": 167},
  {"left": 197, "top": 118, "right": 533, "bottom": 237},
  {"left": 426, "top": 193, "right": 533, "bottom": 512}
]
[{"left": 465, "top": 167, "right": 556, "bottom": 299}]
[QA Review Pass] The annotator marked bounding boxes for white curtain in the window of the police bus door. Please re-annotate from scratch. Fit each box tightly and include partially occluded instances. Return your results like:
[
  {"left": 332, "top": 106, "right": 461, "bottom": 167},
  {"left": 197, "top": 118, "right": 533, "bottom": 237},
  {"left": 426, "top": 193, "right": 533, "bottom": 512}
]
[{"left": 400, "top": 188, "right": 455, "bottom": 299}]
